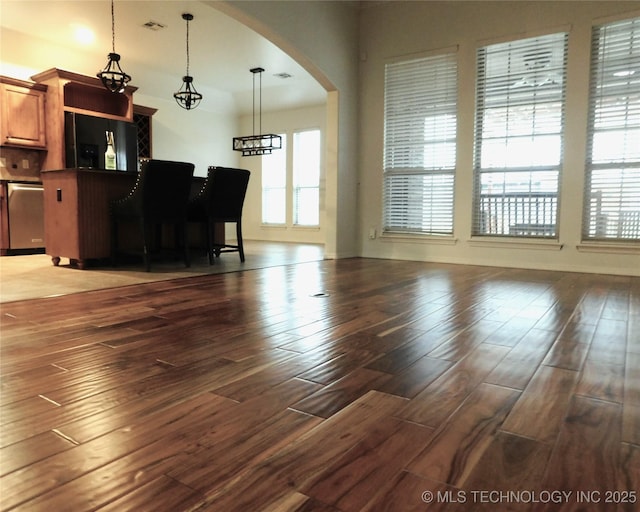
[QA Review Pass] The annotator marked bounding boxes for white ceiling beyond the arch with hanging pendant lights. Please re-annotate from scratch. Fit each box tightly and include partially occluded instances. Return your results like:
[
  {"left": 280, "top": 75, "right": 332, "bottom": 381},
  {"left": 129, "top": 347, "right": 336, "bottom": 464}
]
[{"left": 0, "top": 0, "right": 326, "bottom": 114}]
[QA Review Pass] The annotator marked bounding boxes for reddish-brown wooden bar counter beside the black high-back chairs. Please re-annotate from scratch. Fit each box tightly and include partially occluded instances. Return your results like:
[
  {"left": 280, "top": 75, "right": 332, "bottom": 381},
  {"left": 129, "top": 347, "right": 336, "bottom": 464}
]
[{"left": 41, "top": 169, "right": 137, "bottom": 269}]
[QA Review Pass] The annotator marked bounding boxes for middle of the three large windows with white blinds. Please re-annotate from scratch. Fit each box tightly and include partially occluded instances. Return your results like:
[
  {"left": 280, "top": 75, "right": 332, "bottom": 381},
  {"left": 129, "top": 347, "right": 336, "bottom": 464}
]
[{"left": 473, "top": 33, "right": 568, "bottom": 238}]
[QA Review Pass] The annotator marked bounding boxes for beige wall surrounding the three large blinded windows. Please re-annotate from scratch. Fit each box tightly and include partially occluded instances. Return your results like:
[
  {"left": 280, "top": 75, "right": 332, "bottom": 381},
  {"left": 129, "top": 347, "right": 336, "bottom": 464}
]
[{"left": 358, "top": 1, "right": 640, "bottom": 275}]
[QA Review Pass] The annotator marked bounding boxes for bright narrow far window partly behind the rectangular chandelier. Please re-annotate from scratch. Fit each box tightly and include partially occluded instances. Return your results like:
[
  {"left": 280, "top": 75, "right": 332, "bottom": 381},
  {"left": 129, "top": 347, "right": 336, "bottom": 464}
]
[{"left": 262, "top": 133, "right": 287, "bottom": 224}]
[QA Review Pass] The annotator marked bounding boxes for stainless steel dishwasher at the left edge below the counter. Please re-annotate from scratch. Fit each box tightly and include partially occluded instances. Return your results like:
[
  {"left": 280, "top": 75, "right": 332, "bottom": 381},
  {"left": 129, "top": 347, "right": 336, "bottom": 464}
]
[{"left": 7, "top": 182, "right": 44, "bottom": 251}]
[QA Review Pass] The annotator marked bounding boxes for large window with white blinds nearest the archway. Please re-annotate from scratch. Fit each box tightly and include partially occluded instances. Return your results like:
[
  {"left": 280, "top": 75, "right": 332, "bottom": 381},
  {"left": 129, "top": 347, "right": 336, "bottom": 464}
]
[{"left": 383, "top": 53, "right": 458, "bottom": 235}]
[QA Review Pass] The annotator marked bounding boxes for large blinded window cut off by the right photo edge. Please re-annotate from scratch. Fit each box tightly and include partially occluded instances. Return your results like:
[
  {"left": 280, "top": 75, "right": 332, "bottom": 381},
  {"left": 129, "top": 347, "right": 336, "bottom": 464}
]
[{"left": 582, "top": 18, "right": 640, "bottom": 241}]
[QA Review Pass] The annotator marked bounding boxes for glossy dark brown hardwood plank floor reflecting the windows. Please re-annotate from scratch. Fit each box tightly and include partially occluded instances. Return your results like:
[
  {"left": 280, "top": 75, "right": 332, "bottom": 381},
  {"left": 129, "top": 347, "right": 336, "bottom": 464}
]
[{"left": 0, "top": 259, "right": 640, "bottom": 512}]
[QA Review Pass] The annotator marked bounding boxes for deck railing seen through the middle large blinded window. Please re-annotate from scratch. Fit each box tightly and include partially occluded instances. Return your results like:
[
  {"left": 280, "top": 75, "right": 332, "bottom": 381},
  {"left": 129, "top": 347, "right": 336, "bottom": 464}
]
[{"left": 476, "top": 192, "right": 558, "bottom": 237}]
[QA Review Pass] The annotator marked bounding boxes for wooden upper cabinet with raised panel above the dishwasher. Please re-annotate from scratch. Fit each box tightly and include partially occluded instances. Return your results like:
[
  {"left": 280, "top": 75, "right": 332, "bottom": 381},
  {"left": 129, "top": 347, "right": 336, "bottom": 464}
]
[{"left": 0, "top": 77, "right": 47, "bottom": 149}]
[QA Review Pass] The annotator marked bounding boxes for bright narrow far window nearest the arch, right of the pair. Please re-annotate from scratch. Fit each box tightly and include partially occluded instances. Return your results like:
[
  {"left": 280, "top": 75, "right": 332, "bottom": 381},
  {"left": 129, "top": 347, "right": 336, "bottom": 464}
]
[{"left": 293, "top": 130, "right": 320, "bottom": 226}]
